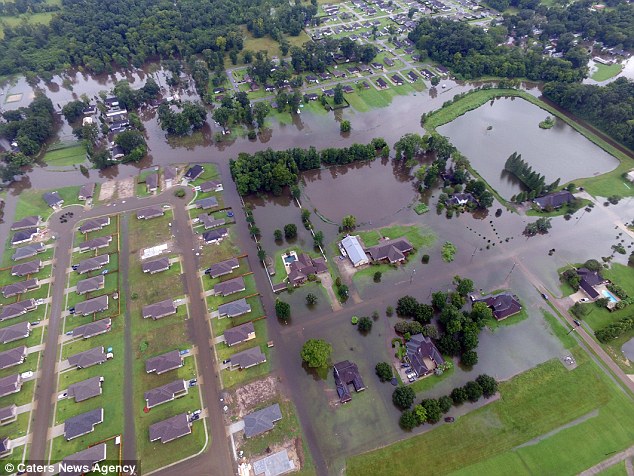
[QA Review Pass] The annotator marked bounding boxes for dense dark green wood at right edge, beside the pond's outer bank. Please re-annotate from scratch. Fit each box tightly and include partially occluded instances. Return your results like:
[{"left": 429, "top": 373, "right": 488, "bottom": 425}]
[{"left": 543, "top": 78, "right": 634, "bottom": 148}]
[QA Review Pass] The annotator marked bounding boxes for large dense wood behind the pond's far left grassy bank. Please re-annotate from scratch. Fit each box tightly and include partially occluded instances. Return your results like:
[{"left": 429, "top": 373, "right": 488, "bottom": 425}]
[{"left": 409, "top": 17, "right": 586, "bottom": 82}]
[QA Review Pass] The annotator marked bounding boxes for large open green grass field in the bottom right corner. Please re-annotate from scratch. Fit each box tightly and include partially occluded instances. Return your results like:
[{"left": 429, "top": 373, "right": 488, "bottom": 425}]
[{"left": 347, "top": 349, "right": 634, "bottom": 476}]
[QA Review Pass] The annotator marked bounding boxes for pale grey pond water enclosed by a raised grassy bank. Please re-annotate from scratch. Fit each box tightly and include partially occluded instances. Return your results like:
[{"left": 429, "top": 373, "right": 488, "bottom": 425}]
[{"left": 438, "top": 98, "right": 619, "bottom": 198}]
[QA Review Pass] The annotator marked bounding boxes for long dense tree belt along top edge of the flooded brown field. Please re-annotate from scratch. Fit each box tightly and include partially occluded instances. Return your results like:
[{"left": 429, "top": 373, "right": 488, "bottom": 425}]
[{"left": 229, "top": 138, "right": 385, "bottom": 195}]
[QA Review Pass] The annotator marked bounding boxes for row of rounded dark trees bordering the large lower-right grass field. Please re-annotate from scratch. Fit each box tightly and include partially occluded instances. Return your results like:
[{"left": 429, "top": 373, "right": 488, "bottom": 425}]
[{"left": 392, "top": 374, "right": 498, "bottom": 431}]
